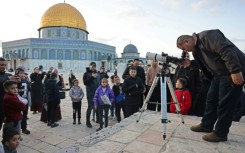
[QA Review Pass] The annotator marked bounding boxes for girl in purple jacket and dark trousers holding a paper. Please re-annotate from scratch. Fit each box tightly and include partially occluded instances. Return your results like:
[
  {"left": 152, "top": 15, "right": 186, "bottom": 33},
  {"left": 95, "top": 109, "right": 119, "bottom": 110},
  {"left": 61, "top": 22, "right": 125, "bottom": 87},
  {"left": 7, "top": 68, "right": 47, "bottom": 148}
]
[{"left": 94, "top": 78, "right": 114, "bottom": 131}]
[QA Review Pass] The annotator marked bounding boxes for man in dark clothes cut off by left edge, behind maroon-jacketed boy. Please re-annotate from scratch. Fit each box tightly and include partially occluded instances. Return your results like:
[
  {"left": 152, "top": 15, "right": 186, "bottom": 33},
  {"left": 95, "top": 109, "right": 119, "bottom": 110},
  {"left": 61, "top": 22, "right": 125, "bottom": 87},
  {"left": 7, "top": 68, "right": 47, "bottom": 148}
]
[{"left": 0, "top": 57, "right": 11, "bottom": 130}]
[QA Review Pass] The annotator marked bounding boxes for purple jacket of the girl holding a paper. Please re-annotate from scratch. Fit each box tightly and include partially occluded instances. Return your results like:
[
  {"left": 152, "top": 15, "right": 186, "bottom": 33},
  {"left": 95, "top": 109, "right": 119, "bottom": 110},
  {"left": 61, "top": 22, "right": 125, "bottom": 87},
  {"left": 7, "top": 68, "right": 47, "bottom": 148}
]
[{"left": 94, "top": 85, "right": 114, "bottom": 105}]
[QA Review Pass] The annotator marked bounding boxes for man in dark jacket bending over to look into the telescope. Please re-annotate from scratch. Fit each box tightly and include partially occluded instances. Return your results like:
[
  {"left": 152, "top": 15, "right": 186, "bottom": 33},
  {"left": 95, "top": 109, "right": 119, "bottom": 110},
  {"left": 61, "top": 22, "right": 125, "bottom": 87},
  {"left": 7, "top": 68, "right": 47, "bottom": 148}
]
[{"left": 177, "top": 30, "right": 245, "bottom": 142}]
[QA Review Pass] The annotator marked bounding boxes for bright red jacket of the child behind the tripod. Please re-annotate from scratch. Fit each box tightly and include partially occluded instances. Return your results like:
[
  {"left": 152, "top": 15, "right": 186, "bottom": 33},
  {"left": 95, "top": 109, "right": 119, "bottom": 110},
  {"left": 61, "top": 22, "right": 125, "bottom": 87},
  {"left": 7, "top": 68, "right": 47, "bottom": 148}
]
[{"left": 170, "top": 89, "right": 191, "bottom": 115}]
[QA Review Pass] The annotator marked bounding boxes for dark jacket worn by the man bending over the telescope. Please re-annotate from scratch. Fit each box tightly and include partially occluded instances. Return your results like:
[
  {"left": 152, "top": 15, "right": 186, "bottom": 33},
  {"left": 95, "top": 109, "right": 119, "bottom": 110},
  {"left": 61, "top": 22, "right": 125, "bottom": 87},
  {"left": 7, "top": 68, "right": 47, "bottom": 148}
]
[{"left": 193, "top": 30, "right": 245, "bottom": 79}]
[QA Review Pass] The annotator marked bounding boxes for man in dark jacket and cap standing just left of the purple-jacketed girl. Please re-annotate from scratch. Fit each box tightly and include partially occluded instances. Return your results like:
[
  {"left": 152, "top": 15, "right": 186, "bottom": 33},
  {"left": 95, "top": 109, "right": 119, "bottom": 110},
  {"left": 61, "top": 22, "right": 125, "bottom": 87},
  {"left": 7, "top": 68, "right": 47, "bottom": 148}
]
[{"left": 83, "top": 62, "right": 100, "bottom": 128}]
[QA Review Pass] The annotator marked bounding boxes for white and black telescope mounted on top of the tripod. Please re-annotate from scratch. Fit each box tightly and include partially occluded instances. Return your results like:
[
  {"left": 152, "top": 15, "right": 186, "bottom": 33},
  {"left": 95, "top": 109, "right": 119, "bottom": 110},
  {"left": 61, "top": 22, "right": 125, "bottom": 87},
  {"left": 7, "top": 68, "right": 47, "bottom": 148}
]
[{"left": 146, "top": 52, "right": 184, "bottom": 64}]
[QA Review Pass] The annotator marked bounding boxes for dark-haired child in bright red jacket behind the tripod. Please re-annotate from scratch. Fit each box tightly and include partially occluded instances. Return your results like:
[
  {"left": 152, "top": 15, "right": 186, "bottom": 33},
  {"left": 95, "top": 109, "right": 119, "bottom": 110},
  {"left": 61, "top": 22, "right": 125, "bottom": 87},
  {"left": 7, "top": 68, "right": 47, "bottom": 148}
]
[{"left": 170, "top": 78, "right": 191, "bottom": 115}]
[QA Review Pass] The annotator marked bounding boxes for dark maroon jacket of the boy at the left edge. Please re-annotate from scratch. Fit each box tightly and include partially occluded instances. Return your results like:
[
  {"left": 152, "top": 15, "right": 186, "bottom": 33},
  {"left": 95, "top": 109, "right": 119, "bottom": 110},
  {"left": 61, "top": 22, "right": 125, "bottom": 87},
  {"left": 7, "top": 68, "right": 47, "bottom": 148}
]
[{"left": 3, "top": 93, "right": 26, "bottom": 122}]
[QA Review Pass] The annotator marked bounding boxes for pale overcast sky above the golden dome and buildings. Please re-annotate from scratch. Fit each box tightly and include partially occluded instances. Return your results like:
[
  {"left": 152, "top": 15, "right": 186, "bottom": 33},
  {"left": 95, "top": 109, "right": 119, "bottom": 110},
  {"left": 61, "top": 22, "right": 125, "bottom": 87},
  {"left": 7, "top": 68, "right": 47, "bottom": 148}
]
[{"left": 0, "top": 0, "right": 245, "bottom": 57}]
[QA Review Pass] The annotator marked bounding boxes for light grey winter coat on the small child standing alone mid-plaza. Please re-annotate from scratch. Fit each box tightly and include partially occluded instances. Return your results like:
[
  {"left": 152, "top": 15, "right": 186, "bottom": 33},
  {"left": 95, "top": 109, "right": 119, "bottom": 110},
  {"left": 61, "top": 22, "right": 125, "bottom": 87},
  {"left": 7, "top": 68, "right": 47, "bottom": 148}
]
[{"left": 69, "top": 86, "right": 84, "bottom": 102}]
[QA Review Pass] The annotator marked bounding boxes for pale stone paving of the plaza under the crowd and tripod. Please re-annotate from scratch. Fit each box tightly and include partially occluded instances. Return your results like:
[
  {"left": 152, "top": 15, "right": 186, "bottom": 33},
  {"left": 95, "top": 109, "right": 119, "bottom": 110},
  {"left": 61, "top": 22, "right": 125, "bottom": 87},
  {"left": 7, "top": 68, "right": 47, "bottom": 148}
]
[{"left": 0, "top": 73, "right": 245, "bottom": 153}]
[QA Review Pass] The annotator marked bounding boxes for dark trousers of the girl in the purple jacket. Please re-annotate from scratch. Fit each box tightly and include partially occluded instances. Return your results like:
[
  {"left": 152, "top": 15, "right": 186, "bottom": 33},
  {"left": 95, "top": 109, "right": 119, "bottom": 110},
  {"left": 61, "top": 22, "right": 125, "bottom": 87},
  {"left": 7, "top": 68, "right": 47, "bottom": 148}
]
[{"left": 97, "top": 104, "right": 110, "bottom": 128}]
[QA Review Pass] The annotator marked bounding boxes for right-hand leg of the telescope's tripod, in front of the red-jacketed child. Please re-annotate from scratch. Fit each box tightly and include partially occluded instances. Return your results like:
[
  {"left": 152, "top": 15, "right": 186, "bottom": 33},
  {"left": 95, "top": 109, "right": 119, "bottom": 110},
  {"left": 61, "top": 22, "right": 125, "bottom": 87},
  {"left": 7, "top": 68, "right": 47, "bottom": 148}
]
[{"left": 166, "top": 77, "right": 185, "bottom": 124}]
